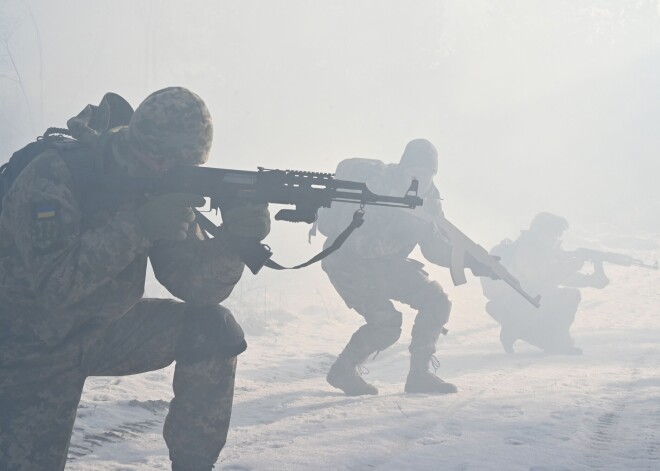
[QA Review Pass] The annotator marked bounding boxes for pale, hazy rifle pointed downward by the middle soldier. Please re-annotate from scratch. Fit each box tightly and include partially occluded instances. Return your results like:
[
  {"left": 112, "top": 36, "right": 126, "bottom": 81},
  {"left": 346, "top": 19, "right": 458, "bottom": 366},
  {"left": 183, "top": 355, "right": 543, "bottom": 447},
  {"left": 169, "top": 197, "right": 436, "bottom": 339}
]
[{"left": 410, "top": 204, "right": 541, "bottom": 307}]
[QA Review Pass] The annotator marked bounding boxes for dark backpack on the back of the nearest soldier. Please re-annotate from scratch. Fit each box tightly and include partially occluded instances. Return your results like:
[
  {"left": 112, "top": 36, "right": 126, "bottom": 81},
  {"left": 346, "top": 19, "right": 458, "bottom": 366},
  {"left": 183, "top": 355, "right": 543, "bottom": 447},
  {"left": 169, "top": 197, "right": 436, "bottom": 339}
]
[{"left": 0, "top": 93, "right": 133, "bottom": 213}]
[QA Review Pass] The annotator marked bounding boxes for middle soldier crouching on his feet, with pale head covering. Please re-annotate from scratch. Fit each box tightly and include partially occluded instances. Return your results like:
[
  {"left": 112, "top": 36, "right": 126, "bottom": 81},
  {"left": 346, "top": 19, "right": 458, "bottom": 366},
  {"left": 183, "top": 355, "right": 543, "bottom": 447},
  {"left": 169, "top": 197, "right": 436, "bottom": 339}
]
[{"left": 319, "top": 139, "right": 490, "bottom": 395}]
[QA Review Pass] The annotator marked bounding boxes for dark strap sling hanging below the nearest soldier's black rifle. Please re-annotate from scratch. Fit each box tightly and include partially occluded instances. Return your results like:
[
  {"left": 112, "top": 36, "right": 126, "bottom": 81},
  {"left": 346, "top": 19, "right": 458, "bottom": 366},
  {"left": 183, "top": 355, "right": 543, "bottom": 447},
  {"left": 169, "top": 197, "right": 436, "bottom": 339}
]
[{"left": 193, "top": 209, "right": 364, "bottom": 275}]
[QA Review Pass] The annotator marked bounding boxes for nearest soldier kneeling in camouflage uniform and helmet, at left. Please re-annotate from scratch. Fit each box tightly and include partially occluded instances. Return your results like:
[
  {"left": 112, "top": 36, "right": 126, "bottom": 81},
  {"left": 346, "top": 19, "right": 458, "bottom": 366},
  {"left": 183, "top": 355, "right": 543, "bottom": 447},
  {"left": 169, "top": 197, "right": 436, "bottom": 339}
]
[{"left": 0, "top": 87, "right": 270, "bottom": 471}]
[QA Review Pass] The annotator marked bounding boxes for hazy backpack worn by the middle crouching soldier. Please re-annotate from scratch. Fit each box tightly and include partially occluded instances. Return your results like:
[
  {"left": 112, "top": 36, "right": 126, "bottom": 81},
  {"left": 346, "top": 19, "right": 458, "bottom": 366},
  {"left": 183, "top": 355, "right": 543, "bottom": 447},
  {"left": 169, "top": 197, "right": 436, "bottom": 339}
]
[{"left": 317, "top": 158, "right": 387, "bottom": 238}]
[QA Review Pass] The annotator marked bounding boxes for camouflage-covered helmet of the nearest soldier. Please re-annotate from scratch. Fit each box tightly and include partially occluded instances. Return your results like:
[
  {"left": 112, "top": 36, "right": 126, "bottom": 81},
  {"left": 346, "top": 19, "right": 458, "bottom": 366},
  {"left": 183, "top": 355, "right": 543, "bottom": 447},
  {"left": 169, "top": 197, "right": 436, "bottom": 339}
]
[{"left": 127, "top": 87, "right": 213, "bottom": 165}]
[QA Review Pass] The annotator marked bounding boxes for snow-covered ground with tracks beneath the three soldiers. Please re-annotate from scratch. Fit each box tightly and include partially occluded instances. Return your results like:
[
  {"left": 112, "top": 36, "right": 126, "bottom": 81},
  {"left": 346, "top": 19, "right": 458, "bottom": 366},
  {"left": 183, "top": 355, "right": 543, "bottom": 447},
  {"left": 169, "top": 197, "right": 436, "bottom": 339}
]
[{"left": 67, "top": 230, "right": 660, "bottom": 471}]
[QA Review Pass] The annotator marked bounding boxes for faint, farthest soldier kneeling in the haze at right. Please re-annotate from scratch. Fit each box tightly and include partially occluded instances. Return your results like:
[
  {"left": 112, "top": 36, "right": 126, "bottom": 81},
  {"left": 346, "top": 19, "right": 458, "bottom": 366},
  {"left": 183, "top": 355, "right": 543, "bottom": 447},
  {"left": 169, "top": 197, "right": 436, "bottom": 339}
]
[{"left": 481, "top": 212, "right": 609, "bottom": 355}]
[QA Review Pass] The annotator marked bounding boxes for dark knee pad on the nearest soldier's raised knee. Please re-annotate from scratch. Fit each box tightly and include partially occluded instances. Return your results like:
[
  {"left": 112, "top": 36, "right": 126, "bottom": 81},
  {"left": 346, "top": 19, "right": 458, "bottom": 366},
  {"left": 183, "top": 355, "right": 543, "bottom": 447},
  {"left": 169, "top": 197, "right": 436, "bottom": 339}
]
[{"left": 175, "top": 305, "right": 247, "bottom": 363}]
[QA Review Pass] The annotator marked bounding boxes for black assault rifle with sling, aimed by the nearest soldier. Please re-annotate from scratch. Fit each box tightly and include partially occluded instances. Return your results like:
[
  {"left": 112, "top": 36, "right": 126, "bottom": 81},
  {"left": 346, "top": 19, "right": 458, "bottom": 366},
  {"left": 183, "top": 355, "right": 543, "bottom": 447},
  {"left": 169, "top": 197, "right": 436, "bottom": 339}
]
[{"left": 148, "top": 166, "right": 423, "bottom": 274}]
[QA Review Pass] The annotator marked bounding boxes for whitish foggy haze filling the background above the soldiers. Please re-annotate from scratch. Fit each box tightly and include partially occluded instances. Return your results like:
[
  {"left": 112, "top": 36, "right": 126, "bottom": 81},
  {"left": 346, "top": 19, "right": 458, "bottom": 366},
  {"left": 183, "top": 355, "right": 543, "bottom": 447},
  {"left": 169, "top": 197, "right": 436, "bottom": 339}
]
[{"left": 0, "top": 0, "right": 660, "bottom": 245}]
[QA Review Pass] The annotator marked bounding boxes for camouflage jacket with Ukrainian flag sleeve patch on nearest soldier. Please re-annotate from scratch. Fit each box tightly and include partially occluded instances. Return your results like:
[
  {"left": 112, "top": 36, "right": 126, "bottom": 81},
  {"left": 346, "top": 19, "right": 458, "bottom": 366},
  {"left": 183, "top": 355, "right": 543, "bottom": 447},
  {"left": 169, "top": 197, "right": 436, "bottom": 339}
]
[{"left": 0, "top": 144, "right": 244, "bottom": 358}]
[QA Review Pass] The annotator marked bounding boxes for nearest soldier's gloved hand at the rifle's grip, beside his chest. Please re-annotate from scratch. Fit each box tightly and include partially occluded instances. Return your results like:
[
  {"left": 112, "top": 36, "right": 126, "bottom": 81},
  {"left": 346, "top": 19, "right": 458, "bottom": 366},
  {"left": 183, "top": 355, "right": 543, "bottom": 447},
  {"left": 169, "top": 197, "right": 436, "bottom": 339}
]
[{"left": 135, "top": 193, "right": 206, "bottom": 242}]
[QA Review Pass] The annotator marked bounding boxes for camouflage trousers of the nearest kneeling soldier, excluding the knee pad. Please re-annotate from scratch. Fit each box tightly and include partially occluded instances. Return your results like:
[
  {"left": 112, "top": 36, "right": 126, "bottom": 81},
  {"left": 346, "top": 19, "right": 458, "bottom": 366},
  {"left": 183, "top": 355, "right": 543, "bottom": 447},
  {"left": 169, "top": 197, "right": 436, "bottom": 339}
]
[{"left": 0, "top": 299, "right": 236, "bottom": 471}]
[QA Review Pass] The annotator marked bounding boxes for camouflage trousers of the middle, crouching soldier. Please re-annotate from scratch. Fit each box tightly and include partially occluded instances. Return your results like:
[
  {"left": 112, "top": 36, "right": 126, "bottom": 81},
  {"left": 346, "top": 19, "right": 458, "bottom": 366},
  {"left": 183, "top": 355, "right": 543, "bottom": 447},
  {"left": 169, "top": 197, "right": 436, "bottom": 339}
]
[{"left": 322, "top": 253, "right": 451, "bottom": 356}]
